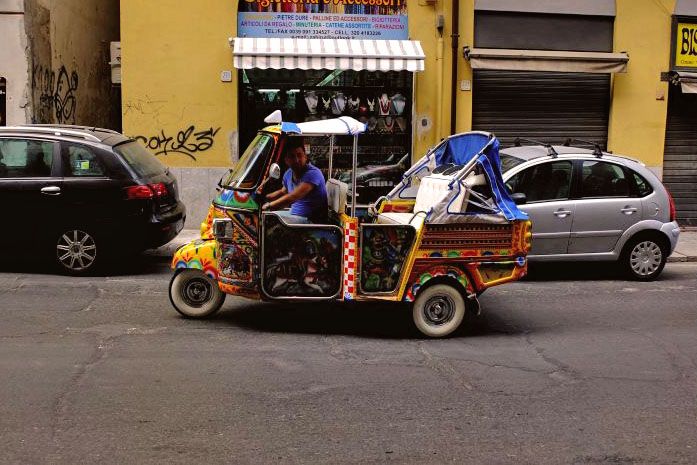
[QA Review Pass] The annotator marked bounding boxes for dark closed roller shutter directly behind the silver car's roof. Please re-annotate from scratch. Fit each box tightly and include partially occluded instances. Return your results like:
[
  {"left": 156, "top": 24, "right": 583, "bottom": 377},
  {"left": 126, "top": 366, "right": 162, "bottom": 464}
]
[{"left": 472, "top": 70, "right": 610, "bottom": 148}]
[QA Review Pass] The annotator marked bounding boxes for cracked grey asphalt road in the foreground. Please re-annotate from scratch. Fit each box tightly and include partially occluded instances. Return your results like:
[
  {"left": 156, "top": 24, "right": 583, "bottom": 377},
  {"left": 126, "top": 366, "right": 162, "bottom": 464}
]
[{"left": 0, "top": 258, "right": 697, "bottom": 464}]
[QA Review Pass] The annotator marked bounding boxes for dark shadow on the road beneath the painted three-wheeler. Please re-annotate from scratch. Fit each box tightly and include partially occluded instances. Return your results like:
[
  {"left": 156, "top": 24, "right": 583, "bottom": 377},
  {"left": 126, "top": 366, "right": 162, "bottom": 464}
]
[{"left": 201, "top": 302, "right": 510, "bottom": 339}]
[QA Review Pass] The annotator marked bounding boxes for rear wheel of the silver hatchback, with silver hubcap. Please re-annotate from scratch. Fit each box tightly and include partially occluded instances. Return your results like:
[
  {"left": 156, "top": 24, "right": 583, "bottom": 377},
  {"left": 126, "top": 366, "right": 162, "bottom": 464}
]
[{"left": 620, "top": 234, "right": 668, "bottom": 281}]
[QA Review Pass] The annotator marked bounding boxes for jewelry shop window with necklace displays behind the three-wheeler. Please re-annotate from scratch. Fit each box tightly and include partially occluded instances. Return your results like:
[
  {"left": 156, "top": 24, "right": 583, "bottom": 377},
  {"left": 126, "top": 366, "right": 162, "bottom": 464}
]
[{"left": 239, "top": 69, "right": 413, "bottom": 205}]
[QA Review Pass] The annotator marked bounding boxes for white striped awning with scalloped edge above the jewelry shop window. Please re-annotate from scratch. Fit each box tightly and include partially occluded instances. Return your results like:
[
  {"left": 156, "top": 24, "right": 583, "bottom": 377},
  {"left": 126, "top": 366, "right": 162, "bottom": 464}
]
[{"left": 232, "top": 37, "right": 425, "bottom": 71}]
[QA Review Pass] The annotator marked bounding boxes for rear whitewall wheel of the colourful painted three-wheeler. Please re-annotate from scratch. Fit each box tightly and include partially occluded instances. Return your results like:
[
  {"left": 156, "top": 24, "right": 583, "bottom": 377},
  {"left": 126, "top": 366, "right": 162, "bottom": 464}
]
[{"left": 412, "top": 284, "right": 466, "bottom": 338}]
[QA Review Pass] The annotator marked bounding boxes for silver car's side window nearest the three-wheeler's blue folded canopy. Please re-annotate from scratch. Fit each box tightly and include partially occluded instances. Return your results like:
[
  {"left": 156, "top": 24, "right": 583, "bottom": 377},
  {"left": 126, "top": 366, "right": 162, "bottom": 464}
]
[{"left": 507, "top": 161, "right": 572, "bottom": 203}]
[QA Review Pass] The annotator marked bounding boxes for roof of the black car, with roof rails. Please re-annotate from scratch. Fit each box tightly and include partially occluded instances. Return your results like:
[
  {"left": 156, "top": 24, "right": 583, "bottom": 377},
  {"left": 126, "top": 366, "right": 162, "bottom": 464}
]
[{"left": 0, "top": 124, "right": 131, "bottom": 146}]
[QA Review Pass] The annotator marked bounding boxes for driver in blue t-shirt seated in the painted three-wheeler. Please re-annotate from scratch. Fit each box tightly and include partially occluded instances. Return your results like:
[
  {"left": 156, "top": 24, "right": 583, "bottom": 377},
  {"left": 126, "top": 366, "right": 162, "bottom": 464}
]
[{"left": 261, "top": 137, "right": 328, "bottom": 224}]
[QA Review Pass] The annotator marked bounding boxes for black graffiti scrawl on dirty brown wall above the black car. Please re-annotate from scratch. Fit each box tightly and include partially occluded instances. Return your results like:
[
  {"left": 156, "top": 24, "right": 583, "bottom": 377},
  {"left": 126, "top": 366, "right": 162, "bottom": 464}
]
[{"left": 31, "top": 64, "right": 80, "bottom": 124}]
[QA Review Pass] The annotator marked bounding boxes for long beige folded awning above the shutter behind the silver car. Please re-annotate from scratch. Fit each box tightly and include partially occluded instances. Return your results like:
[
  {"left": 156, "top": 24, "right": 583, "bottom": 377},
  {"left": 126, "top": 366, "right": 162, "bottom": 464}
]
[{"left": 465, "top": 48, "right": 629, "bottom": 73}]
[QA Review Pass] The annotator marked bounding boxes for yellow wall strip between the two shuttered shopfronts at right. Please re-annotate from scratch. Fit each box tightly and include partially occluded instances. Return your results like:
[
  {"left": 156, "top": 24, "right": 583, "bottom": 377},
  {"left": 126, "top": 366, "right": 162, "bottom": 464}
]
[{"left": 608, "top": 0, "right": 675, "bottom": 168}]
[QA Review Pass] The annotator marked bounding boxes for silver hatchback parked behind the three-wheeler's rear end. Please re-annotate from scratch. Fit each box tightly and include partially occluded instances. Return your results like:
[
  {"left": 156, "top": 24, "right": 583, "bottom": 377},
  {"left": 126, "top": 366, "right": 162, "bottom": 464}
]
[{"left": 501, "top": 145, "right": 680, "bottom": 281}]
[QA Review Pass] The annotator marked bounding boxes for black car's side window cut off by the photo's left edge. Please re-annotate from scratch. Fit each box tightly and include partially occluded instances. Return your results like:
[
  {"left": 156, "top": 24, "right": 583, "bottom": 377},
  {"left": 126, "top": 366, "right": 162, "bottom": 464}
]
[{"left": 0, "top": 139, "right": 53, "bottom": 178}]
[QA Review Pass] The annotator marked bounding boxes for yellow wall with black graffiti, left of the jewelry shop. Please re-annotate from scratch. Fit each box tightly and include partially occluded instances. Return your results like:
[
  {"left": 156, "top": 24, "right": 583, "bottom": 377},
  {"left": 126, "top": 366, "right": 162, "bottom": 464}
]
[{"left": 121, "top": 0, "right": 237, "bottom": 167}]
